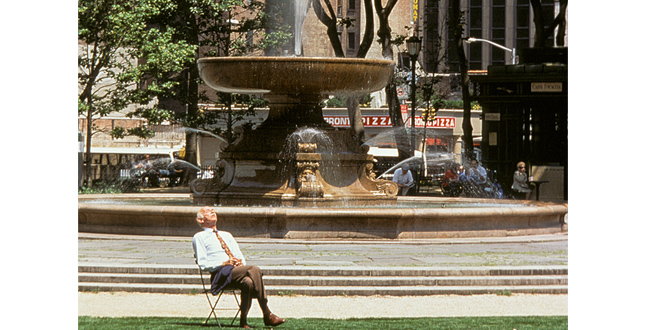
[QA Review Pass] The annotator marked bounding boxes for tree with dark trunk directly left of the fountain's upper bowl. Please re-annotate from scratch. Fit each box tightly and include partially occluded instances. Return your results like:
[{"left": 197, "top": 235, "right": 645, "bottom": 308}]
[{"left": 117, "top": 0, "right": 280, "bottom": 179}]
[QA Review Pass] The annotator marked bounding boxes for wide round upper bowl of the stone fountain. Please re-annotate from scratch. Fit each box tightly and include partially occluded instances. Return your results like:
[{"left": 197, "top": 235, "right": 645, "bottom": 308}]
[{"left": 197, "top": 57, "right": 395, "bottom": 94}]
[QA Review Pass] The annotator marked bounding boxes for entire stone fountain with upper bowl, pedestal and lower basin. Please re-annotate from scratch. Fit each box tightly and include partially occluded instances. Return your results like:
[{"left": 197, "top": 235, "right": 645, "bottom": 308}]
[{"left": 78, "top": 7, "right": 568, "bottom": 239}]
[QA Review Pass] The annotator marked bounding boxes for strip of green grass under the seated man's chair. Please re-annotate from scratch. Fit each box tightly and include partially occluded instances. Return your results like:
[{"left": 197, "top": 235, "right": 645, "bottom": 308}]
[{"left": 78, "top": 316, "right": 569, "bottom": 330}]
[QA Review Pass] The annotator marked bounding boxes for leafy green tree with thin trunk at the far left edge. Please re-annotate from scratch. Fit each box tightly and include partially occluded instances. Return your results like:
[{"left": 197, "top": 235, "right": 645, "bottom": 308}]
[{"left": 78, "top": 0, "right": 195, "bottom": 185}]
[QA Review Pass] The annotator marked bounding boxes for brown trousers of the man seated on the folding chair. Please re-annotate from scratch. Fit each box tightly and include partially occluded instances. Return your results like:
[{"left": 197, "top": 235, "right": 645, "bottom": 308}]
[{"left": 228, "top": 266, "right": 271, "bottom": 324}]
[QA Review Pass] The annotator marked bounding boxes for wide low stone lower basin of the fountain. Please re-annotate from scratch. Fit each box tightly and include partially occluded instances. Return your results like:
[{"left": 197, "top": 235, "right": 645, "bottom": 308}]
[{"left": 78, "top": 194, "right": 568, "bottom": 239}]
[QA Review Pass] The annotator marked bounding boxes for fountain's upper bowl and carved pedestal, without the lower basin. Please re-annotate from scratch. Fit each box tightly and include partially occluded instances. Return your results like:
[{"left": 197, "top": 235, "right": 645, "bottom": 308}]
[{"left": 191, "top": 57, "right": 398, "bottom": 207}]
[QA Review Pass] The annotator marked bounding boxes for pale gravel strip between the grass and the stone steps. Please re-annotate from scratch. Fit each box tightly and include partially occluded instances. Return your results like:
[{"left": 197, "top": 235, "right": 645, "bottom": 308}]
[{"left": 78, "top": 292, "right": 568, "bottom": 319}]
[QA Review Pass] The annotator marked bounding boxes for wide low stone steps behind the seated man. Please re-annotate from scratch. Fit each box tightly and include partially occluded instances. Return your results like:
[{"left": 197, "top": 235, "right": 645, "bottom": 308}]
[{"left": 78, "top": 265, "right": 568, "bottom": 296}]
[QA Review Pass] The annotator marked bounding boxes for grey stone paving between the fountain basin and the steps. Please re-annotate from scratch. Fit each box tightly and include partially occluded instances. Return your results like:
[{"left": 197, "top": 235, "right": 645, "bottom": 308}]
[{"left": 78, "top": 233, "right": 568, "bottom": 267}]
